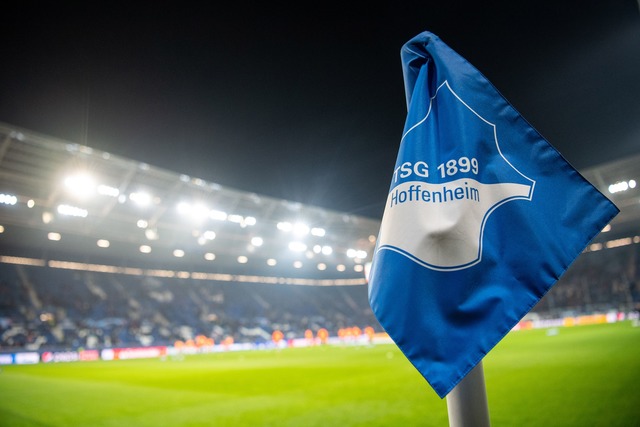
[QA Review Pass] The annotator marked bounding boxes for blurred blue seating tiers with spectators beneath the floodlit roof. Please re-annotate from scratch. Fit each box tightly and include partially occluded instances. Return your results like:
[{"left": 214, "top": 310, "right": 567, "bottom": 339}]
[{"left": 0, "top": 245, "right": 640, "bottom": 351}]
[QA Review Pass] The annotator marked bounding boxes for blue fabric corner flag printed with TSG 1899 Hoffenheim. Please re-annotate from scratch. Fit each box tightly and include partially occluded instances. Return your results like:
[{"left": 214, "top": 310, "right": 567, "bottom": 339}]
[{"left": 369, "top": 32, "right": 619, "bottom": 398}]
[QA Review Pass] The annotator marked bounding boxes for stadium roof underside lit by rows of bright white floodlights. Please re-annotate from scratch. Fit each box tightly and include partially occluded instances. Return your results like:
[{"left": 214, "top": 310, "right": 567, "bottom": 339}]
[{"left": 0, "top": 123, "right": 640, "bottom": 284}]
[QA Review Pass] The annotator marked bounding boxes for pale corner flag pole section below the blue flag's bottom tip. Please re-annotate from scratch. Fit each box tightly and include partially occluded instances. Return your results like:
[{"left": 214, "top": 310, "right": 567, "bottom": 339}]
[{"left": 447, "top": 360, "right": 491, "bottom": 427}]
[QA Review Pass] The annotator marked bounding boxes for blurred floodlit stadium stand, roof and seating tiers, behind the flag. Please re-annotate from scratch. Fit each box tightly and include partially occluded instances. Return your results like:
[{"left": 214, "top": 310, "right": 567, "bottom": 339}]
[{"left": 0, "top": 123, "right": 640, "bottom": 353}]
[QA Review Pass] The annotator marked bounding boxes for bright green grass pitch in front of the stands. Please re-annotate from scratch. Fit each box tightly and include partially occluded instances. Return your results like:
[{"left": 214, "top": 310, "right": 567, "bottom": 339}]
[{"left": 0, "top": 321, "right": 640, "bottom": 427}]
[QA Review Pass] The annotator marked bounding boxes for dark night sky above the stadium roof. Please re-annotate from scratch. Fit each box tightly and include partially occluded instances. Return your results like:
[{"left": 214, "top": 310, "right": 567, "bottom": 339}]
[{"left": 0, "top": 0, "right": 640, "bottom": 218}]
